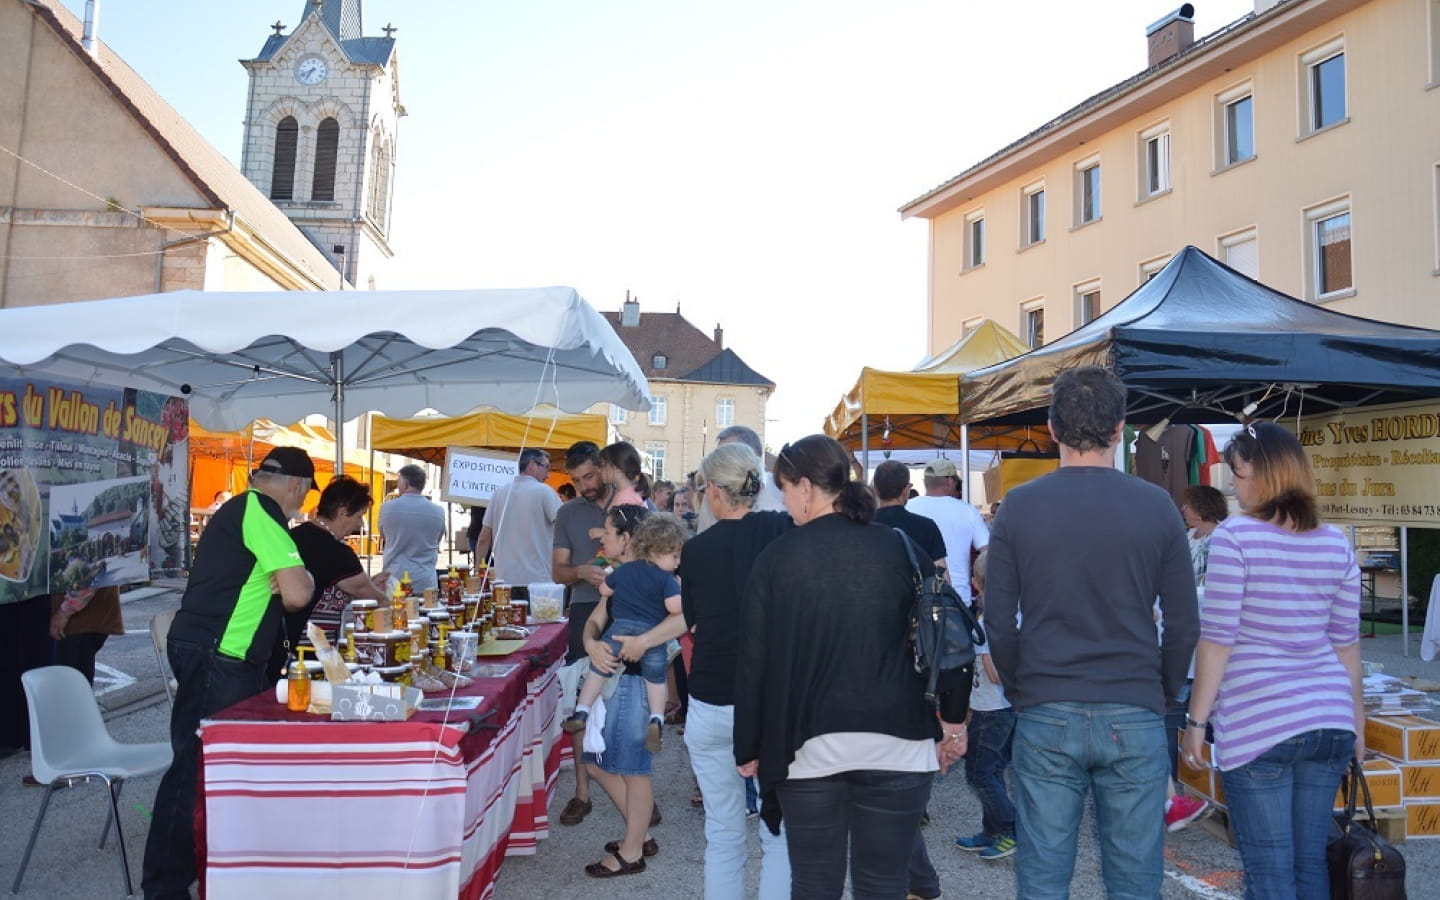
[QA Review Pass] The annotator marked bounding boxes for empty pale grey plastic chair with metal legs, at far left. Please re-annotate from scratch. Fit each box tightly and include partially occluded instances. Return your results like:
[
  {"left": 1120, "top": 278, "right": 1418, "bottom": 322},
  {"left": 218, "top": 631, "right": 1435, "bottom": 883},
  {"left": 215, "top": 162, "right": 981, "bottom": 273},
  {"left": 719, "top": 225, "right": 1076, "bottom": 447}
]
[{"left": 10, "top": 665, "right": 171, "bottom": 897}]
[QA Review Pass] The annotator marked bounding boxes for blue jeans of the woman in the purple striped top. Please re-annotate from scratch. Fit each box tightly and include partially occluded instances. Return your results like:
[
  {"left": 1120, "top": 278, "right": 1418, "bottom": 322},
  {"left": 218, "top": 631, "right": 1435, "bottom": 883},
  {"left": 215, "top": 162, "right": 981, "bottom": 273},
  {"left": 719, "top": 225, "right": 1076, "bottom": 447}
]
[{"left": 1220, "top": 729, "right": 1355, "bottom": 900}]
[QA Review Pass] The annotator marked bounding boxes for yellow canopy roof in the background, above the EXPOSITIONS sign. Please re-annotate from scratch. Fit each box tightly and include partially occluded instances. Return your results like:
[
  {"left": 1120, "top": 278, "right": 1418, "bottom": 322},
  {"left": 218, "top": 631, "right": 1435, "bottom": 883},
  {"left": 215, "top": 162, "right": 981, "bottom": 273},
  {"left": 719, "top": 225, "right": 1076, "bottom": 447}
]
[{"left": 370, "top": 408, "right": 609, "bottom": 469}]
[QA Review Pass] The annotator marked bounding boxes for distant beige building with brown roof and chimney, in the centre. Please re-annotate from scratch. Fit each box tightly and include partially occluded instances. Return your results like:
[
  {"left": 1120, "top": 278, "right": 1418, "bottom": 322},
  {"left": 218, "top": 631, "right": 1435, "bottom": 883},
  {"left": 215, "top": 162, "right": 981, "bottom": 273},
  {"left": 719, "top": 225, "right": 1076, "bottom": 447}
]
[{"left": 590, "top": 295, "right": 775, "bottom": 482}]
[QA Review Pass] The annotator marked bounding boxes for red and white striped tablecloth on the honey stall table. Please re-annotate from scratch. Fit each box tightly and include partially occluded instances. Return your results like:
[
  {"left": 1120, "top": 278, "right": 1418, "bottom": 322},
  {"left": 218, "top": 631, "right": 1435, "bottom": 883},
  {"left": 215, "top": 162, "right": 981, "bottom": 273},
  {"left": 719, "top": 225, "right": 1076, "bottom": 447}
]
[{"left": 202, "top": 626, "right": 564, "bottom": 900}]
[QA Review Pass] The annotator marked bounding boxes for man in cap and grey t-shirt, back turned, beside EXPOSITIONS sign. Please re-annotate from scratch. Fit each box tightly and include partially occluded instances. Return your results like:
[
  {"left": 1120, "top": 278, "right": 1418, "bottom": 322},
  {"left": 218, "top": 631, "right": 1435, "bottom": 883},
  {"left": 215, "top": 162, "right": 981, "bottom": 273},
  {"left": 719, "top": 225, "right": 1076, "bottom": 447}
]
[{"left": 475, "top": 446, "right": 560, "bottom": 587}]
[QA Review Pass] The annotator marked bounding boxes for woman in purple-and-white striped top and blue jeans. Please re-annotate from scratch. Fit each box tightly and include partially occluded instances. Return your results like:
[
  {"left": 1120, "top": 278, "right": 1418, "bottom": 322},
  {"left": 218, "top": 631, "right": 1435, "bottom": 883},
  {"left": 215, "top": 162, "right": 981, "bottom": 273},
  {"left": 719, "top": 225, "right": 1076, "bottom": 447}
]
[{"left": 1181, "top": 423, "right": 1365, "bottom": 900}]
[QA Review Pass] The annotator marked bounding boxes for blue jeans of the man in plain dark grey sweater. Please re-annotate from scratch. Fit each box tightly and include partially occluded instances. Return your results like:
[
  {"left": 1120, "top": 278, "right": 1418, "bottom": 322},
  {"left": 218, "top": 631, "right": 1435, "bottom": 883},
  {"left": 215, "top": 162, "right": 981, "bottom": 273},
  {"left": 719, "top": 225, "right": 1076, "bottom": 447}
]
[{"left": 1014, "top": 701, "right": 1166, "bottom": 900}]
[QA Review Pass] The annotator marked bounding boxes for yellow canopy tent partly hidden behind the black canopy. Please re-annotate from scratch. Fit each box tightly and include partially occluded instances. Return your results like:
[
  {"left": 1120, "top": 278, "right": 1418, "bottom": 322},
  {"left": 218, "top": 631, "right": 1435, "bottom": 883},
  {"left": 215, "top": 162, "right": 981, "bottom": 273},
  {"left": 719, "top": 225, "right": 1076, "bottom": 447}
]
[{"left": 825, "top": 318, "right": 1050, "bottom": 452}]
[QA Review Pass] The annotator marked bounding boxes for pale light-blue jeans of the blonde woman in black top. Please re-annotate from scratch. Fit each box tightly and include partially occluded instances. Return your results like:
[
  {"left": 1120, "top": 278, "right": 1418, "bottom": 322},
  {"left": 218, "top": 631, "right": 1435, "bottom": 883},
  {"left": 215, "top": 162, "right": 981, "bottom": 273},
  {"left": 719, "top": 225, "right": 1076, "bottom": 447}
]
[{"left": 685, "top": 697, "right": 791, "bottom": 900}]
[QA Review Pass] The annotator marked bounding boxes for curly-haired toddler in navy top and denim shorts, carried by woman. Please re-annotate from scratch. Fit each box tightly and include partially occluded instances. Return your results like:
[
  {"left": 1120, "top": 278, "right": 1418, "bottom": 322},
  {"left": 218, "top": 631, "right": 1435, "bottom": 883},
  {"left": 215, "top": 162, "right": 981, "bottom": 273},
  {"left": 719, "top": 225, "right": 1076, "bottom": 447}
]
[{"left": 560, "top": 505, "right": 688, "bottom": 753}]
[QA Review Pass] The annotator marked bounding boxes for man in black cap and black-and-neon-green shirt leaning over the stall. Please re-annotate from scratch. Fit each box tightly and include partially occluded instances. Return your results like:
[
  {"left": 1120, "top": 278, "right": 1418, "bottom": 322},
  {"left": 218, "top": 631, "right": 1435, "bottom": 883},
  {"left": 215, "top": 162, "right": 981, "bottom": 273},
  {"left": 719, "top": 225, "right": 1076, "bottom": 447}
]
[{"left": 143, "top": 446, "right": 315, "bottom": 900}]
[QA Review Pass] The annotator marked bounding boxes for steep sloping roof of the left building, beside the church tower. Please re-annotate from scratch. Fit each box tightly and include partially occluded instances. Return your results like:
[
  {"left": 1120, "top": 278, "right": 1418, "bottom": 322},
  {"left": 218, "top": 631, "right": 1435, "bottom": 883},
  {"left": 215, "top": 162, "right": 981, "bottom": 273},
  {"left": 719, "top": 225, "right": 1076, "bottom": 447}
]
[{"left": 24, "top": 0, "right": 341, "bottom": 289}]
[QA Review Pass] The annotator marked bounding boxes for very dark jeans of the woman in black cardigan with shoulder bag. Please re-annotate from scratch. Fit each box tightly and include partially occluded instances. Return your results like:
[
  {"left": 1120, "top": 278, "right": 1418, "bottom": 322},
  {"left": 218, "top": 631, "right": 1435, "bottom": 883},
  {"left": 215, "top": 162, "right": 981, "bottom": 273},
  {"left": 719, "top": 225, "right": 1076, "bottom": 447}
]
[{"left": 777, "top": 766, "right": 935, "bottom": 900}]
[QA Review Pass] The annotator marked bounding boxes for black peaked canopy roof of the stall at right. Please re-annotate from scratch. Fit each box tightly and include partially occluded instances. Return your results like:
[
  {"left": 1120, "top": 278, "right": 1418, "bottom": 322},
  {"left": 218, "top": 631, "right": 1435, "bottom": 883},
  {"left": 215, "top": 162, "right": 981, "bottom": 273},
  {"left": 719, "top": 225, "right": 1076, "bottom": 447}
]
[{"left": 960, "top": 246, "right": 1440, "bottom": 426}]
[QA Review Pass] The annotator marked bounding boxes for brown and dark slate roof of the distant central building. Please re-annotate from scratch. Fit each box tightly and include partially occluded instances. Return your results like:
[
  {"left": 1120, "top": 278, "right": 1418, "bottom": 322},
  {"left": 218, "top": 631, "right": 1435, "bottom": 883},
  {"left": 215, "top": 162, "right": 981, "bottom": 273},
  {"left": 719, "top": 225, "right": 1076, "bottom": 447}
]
[{"left": 602, "top": 312, "right": 775, "bottom": 387}]
